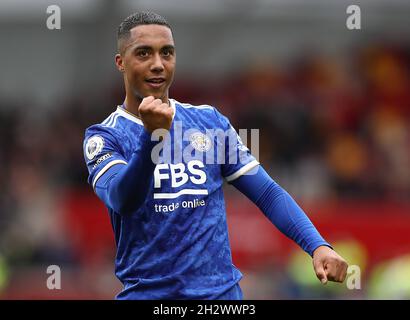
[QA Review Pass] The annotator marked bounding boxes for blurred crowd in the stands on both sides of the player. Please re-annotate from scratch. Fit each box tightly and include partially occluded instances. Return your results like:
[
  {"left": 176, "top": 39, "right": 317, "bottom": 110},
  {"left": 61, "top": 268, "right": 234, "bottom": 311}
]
[{"left": 0, "top": 45, "right": 410, "bottom": 298}]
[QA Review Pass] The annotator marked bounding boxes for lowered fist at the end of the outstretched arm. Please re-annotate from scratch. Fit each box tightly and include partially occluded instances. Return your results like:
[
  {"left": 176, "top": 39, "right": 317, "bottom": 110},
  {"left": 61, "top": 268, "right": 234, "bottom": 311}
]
[{"left": 313, "top": 246, "right": 347, "bottom": 284}]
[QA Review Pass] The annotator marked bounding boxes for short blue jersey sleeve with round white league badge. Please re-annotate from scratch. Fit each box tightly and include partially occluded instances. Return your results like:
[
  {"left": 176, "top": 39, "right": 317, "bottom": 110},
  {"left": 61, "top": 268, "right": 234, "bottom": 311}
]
[{"left": 83, "top": 126, "right": 127, "bottom": 188}]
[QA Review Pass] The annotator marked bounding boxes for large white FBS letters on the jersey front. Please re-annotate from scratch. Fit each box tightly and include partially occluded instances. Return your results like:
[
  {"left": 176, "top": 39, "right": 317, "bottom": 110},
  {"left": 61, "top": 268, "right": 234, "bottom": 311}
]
[{"left": 154, "top": 160, "right": 206, "bottom": 188}]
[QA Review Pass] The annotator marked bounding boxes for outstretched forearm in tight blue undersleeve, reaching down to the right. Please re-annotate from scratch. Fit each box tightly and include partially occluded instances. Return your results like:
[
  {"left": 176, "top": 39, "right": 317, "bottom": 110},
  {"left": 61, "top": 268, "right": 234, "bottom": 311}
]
[{"left": 232, "top": 166, "right": 330, "bottom": 256}]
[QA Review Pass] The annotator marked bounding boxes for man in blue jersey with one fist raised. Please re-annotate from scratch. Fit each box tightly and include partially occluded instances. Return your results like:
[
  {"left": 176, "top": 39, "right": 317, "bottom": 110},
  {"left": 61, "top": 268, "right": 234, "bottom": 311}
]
[{"left": 84, "top": 12, "right": 347, "bottom": 299}]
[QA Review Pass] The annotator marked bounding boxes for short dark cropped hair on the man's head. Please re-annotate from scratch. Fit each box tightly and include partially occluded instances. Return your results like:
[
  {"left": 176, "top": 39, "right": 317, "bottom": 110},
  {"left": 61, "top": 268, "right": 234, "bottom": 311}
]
[{"left": 117, "top": 11, "right": 172, "bottom": 52}]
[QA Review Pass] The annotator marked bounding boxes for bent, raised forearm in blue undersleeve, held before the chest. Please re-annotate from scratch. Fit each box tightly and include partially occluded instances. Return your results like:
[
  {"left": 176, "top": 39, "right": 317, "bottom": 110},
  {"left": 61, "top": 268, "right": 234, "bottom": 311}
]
[{"left": 95, "top": 131, "right": 156, "bottom": 214}]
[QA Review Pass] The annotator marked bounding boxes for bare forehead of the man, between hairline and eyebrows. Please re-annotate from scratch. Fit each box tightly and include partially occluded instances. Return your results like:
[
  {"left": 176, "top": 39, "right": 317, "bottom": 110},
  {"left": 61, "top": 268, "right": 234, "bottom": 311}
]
[{"left": 128, "top": 24, "right": 174, "bottom": 47}]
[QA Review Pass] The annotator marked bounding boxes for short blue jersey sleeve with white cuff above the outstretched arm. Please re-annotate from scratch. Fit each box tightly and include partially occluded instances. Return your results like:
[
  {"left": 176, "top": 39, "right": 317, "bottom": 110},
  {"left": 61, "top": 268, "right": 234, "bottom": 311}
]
[{"left": 215, "top": 110, "right": 259, "bottom": 182}]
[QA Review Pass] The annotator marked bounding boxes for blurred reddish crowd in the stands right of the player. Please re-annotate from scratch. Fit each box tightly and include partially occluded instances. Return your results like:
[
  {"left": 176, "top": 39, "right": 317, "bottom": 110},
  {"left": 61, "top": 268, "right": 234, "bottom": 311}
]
[{"left": 215, "top": 46, "right": 410, "bottom": 201}]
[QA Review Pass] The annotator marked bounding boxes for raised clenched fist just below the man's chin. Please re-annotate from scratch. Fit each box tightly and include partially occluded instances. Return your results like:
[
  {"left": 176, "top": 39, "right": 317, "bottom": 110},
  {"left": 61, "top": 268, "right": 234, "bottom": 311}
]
[{"left": 138, "top": 96, "right": 173, "bottom": 133}]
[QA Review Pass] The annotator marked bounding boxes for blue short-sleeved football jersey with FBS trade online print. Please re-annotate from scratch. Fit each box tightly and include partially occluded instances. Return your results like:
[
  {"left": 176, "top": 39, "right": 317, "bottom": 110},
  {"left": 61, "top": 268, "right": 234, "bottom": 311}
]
[{"left": 83, "top": 99, "right": 259, "bottom": 299}]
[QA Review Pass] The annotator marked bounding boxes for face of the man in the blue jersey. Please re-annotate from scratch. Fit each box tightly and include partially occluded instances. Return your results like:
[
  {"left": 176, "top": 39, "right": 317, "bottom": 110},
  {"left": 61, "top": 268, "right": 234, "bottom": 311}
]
[{"left": 115, "top": 24, "right": 176, "bottom": 101}]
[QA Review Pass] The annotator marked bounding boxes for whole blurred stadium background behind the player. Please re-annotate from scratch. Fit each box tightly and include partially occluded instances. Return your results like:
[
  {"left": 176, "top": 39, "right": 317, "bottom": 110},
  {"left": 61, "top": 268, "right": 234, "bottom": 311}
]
[{"left": 0, "top": 0, "right": 410, "bottom": 299}]
